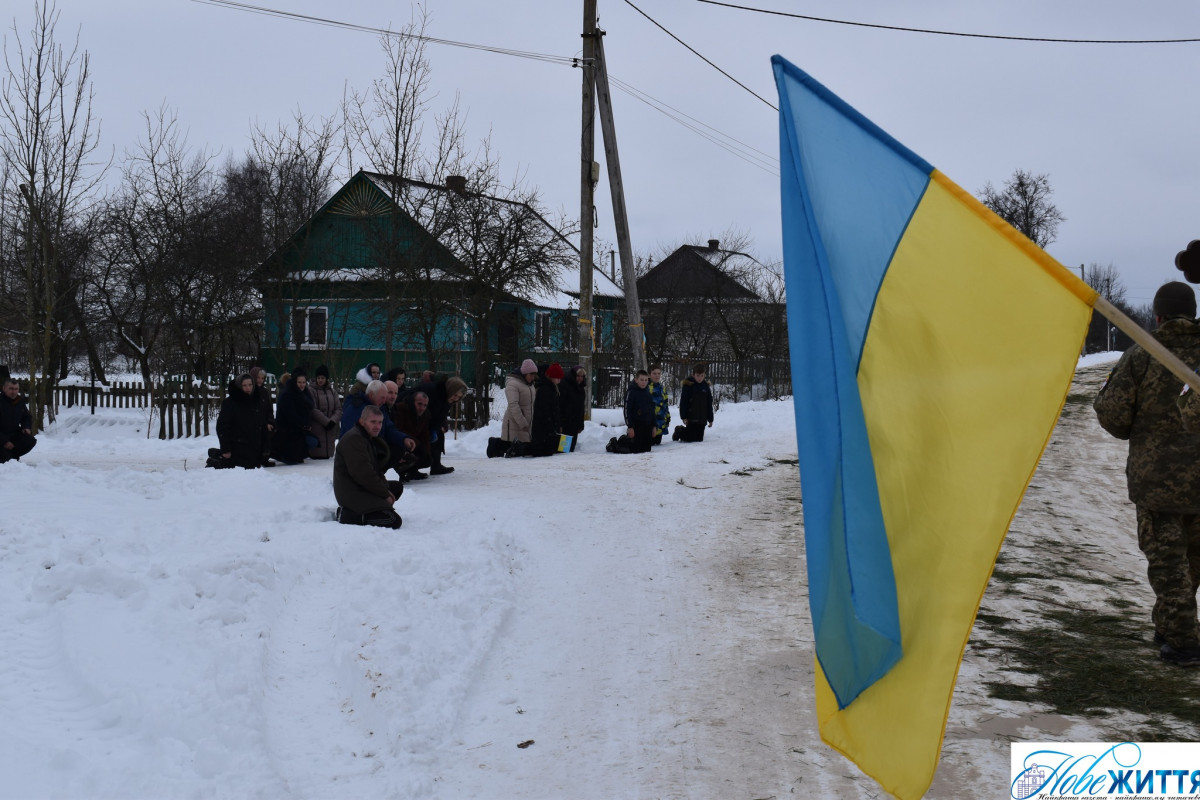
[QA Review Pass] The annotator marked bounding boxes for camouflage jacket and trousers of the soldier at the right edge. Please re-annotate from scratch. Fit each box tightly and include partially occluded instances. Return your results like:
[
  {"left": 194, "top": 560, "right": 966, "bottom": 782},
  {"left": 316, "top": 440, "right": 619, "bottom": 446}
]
[{"left": 1092, "top": 318, "right": 1200, "bottom": 648}]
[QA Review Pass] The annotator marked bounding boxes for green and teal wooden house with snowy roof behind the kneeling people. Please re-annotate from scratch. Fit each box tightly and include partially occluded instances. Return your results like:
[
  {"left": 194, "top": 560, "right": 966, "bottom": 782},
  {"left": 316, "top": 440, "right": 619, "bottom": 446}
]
[{"left": 256, "top": 170, "right": 623, "bottom": 386}]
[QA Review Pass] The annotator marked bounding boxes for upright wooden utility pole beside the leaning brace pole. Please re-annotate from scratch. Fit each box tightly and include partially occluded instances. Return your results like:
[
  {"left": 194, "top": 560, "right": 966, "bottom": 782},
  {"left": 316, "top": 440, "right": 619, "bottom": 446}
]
[{"left": 572, "top": 0, "right": 596, "bottom": 420}]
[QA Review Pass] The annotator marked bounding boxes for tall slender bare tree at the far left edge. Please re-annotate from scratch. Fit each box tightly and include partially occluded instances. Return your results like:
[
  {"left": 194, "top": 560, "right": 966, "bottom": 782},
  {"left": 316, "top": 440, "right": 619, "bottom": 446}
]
[{"left": 0, "top": 0, "right": 103, "bottom": 426}]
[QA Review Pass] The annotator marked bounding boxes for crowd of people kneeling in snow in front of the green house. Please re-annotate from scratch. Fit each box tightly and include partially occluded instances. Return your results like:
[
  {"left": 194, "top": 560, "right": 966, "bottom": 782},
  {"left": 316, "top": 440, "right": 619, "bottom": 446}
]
[{"left": 208, "top": 359, "right": 713, "bottom": 528}]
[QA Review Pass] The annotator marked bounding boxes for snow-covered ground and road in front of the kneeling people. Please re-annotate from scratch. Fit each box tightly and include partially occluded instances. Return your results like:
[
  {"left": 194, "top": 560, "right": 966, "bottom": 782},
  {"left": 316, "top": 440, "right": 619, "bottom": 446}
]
[{"left": 0, "top": 356, "right": 1190, "bottom": 800}]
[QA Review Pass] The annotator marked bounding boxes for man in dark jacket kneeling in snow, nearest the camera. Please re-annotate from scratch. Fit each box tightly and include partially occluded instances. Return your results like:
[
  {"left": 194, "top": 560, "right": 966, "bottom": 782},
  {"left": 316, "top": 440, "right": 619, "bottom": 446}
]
[{"left": 334, "top": 405, "right": 404, "bottom": 528}]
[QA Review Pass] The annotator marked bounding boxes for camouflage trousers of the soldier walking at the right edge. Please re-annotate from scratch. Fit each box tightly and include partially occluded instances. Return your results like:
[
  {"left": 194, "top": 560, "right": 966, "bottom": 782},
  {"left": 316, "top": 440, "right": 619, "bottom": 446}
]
[{"left": 1138, "top": 506, "right": 1200, "bottom": 648}]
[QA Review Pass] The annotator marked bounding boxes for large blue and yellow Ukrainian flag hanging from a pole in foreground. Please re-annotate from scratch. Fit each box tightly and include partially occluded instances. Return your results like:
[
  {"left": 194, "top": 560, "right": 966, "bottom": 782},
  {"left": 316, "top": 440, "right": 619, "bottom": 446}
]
[{"left": 772, "top": 55, "right": 1096, "bottom": 798}]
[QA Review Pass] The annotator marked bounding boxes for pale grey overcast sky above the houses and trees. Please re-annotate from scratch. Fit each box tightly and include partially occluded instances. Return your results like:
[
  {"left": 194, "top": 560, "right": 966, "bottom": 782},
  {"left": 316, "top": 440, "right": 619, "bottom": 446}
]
[{"left": 16, "top": 0, "right": 1200, "bottom": 305}]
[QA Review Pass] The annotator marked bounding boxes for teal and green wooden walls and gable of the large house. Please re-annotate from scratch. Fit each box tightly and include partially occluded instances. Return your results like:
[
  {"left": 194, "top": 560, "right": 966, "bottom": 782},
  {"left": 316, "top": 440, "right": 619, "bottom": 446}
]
[{"left": 259, "top": 174, "right": 624, "bottom": 383}]
